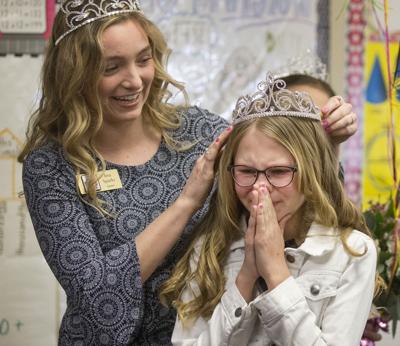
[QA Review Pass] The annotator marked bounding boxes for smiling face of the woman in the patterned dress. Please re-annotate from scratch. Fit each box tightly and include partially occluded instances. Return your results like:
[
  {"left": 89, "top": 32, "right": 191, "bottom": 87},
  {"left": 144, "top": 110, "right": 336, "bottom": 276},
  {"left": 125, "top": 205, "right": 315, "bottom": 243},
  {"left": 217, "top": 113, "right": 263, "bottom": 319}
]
[{"left": 99, "top": 20, "right": 155, "bottom": 124}]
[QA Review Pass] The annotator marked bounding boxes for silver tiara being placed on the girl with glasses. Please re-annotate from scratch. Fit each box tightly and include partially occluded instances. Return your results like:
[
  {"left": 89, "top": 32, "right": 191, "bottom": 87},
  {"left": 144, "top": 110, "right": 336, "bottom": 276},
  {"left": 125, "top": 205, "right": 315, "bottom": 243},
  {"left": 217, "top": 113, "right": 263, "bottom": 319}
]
[{"left": 232, "top": 72, "right": 321, "bottom": 125}]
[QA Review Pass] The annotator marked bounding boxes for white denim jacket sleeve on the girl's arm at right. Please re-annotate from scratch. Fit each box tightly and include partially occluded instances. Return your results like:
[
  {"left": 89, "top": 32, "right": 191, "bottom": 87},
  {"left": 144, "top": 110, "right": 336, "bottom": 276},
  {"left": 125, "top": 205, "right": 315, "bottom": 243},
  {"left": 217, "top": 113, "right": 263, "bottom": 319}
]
[{"left": 252, "top": 232, "right": 377, "bottom": 346}]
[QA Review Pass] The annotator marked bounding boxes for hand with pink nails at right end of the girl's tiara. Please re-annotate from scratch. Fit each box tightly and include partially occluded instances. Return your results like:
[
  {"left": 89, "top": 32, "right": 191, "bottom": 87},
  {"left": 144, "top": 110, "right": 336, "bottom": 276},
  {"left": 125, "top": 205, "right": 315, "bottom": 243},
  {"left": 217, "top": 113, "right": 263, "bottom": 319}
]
[{"left": 321, "top": 96, "right": 358, "bottom": 146}]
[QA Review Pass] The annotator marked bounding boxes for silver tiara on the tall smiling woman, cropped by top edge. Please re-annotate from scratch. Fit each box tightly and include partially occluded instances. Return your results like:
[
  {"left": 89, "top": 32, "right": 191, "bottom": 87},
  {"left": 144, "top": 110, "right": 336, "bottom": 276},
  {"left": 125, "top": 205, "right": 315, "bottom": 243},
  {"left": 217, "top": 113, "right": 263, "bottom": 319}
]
[{"left": 55, "top": 0, "right": 142, "bottom": 45}]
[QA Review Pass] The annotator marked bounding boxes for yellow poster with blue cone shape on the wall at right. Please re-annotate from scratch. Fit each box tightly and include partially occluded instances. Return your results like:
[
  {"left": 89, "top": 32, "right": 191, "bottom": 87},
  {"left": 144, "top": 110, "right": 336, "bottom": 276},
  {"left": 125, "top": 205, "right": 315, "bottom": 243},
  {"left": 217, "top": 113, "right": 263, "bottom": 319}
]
[{"left": 362, "top": 34, "right": 400, "bottom": 208}]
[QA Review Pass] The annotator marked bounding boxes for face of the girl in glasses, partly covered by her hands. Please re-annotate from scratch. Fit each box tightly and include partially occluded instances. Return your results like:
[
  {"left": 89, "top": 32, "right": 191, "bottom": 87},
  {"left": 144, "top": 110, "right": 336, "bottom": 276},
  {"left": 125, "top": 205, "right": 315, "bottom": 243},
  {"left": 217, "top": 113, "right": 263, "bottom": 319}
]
[{"left": 234, "top": 127, "right": 304, "bottom": 227}]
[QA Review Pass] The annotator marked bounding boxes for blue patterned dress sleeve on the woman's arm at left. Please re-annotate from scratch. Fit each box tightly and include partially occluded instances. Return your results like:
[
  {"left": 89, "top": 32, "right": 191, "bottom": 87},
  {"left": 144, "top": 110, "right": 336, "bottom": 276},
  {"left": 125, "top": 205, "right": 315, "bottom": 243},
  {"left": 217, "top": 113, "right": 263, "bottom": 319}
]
[{"left": 23, "top": 149, "right": 143, "bottom": 345}]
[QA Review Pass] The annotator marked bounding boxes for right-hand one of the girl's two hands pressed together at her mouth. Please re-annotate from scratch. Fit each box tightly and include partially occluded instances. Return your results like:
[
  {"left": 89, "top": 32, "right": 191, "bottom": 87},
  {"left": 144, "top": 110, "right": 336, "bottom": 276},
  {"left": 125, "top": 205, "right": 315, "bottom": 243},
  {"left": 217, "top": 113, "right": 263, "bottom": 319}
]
[{"left": 254, "top": 187, "right": 290, "bottom": 290}]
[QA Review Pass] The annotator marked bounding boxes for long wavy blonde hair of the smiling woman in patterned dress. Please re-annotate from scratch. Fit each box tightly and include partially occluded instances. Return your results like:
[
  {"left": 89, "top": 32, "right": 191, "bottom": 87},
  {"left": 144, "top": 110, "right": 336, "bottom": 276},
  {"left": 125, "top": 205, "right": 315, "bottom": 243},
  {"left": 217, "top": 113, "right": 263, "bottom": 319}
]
[{"left": 18, "top": 11, "right": 187, "bottom": 211}]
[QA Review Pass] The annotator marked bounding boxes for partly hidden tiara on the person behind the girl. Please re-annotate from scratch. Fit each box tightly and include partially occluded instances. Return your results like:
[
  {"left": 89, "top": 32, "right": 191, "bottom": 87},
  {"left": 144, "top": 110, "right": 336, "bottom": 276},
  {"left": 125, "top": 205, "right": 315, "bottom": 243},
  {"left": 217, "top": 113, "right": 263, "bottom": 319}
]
[{"left": 274, "top": 49, "right": 328, "bottom": 82}]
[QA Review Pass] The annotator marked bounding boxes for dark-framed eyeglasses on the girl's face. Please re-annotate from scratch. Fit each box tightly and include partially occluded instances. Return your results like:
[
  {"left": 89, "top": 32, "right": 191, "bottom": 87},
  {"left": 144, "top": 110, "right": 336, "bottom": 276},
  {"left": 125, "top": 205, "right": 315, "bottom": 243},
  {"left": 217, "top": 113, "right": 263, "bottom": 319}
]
[{"left": 228, "top": 165, "right": 297, "bottom": 187}]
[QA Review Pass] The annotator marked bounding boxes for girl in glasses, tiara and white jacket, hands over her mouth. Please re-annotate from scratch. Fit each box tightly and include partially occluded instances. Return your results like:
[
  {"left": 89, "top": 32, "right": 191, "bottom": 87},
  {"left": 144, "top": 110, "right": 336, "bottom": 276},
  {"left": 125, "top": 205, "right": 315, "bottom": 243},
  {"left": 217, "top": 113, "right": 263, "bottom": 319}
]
[{"left": 161, "top": 72, "right": 376, "bottom": 346}]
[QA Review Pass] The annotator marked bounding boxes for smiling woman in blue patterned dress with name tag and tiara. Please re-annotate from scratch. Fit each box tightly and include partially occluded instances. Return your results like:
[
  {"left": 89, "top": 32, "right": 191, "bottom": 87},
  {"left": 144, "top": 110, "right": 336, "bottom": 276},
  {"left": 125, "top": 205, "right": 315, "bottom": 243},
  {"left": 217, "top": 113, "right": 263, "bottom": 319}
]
[{"left": 19, "top": 0, "right": 355, "bottom": 346}]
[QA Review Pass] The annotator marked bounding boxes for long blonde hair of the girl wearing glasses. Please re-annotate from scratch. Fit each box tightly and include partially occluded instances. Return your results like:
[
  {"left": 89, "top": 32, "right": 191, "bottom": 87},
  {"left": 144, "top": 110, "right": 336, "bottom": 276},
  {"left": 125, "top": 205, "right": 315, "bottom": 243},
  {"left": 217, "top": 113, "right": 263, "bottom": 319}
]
[{"left": 160, "top": 117, "right": 369, "bottom": 322}]
